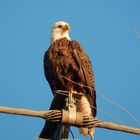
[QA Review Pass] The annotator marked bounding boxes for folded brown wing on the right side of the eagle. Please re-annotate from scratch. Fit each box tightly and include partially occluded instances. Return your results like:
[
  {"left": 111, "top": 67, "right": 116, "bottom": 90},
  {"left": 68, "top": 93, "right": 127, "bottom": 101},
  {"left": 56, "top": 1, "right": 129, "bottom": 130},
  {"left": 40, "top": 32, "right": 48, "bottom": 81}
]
[{"left": 71, "top": 41, "right": 96, "bottom": 116}]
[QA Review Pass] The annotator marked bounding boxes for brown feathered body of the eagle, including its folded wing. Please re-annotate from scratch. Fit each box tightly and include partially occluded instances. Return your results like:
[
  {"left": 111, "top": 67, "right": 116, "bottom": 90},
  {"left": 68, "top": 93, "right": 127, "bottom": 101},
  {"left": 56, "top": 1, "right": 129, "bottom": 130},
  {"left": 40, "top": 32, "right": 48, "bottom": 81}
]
[{"left": 44, "top": 38, "right": 96, "bottom": 116}]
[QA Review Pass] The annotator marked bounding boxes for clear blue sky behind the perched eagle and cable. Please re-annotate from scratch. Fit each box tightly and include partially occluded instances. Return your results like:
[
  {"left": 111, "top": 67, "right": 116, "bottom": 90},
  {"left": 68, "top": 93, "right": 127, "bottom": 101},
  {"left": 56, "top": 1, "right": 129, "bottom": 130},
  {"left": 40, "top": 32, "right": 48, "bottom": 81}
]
[{"left": 0, "top": 0, "right": 140, "bottom": 140}]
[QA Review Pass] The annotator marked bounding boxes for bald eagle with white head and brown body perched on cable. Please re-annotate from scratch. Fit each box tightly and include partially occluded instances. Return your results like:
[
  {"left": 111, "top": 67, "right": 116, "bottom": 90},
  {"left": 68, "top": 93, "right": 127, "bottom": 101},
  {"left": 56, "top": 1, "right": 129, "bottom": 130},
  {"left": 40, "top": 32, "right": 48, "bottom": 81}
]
[{"left": 39, "top": 21, "right": 96, "bottom": 139}]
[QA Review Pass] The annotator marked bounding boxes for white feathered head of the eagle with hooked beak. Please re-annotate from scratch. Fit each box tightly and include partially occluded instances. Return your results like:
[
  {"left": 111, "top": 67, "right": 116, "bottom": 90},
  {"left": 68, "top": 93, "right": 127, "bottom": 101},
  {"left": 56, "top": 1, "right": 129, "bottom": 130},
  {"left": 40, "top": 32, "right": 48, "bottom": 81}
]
[{"left": 51, "top": 21, "right": 70, "bottom": 44}]
